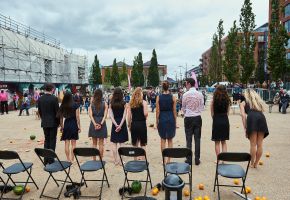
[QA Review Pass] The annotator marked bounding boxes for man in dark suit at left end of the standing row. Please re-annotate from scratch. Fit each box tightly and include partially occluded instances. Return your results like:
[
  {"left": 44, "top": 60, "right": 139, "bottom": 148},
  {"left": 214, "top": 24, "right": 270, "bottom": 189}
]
[{"left": 38, "top": 83, "right": 59, "bottom": 164}]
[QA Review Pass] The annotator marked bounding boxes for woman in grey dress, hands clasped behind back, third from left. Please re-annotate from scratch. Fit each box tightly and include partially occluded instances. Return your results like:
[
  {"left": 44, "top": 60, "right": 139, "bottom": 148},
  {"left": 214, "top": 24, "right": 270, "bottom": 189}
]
[{"left": 89, "top": 89, "right": 108, "bottom": 160}]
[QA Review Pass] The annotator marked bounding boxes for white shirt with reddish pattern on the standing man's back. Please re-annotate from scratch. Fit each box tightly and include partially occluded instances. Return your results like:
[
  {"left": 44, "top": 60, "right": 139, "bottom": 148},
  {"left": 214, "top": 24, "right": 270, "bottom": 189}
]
[{"left": 182, "top": 87, "right": 204, "bottom": 117}]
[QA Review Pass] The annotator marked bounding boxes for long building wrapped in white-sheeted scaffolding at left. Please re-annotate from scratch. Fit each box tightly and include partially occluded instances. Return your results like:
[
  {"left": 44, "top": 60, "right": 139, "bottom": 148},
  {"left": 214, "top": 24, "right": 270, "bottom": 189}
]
[{"left": 0, "top": 14, "right": 88, "bottom": 84}]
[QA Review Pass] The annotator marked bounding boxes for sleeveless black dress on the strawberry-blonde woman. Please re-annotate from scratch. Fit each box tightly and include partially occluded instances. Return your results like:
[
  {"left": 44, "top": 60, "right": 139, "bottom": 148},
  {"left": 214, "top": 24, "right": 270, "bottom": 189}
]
[{"left": 131, "top": 105, "right": 147, "bottom": 146}]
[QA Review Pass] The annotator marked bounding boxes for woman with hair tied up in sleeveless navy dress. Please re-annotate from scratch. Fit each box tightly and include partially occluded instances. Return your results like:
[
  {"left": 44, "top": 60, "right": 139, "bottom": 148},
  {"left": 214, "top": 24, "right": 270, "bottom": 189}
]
[{"left": 156, "top": 81, "right": 177, "bottom": 163}]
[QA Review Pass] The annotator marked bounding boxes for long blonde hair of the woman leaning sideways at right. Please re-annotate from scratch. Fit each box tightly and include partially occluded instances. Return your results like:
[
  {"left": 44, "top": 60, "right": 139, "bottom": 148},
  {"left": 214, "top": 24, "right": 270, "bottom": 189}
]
[{"left": 244, "top": 88, "right": 267, "bottom": 112}]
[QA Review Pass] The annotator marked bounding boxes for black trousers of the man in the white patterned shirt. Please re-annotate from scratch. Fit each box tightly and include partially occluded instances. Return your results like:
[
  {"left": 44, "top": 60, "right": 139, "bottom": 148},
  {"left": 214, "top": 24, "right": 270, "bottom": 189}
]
[{"left": 184, "top": 116, "right": 202, "bottom": 161}]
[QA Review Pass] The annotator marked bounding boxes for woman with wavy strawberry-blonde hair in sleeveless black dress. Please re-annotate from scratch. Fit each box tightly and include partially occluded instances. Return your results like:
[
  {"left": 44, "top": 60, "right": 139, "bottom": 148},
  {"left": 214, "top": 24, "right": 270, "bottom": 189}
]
[{"left": 128, "top": 87, "right": 148, "bottom": 154}]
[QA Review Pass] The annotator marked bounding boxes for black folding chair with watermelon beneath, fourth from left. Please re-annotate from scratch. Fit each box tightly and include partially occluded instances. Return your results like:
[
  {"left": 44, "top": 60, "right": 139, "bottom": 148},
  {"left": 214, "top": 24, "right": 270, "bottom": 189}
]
[{"left": 118, "top": 147, "right": 152, "bottom": 199}]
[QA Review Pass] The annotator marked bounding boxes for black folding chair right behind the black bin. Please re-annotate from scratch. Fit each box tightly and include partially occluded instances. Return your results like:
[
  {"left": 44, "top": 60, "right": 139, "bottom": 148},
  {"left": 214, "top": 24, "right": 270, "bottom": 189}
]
[{"left": 162, "top": 148, "right": 192, "bottom": 199}]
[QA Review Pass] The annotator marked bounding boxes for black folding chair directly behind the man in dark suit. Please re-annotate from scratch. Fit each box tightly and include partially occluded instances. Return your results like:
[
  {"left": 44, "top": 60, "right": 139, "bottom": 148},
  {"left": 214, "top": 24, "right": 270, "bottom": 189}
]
[{"left": 34, "top": 148, "right": 73, "bottom": 199}]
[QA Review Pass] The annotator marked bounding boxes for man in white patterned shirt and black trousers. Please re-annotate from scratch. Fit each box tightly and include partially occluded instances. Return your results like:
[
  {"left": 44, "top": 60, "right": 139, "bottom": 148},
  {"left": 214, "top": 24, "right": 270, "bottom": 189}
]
[{"left": 182, "top": 78, "right": 204, "bottom": 165}]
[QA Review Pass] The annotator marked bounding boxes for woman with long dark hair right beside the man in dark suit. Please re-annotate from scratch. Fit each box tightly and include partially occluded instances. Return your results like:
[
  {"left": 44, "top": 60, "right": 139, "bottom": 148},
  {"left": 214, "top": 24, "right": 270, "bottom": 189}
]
[{"left": 58, "top": 92, "right": 81, "bottom": 162}]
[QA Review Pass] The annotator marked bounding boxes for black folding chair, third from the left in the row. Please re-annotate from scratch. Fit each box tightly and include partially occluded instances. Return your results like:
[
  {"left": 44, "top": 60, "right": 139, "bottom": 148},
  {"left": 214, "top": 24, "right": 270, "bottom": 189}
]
[{"left": 74, "top": 148, "right": 110, "bottom": 199}]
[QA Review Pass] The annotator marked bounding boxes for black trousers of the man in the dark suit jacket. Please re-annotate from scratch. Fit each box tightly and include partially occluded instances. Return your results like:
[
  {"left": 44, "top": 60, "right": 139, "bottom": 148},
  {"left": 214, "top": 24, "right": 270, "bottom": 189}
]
[{"left": 43, "top": 127, "right": 57, "bottom": 164}]
